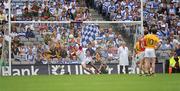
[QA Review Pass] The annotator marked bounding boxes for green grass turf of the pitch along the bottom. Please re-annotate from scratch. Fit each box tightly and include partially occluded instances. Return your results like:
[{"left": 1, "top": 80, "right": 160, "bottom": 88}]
[{"left": 0, "top": 74, "right": 180, "bottom": 91}]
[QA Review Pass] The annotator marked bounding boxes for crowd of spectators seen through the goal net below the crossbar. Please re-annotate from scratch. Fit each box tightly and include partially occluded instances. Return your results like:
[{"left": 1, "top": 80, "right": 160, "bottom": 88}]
[{"left": 12, "top": 23, "right": 134, "bottom": 64}]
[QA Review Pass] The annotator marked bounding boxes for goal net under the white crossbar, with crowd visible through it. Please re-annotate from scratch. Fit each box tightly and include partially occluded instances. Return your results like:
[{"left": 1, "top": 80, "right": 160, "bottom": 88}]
[{"left": 2, "top": 21, "right": 143, "bottom": 76}]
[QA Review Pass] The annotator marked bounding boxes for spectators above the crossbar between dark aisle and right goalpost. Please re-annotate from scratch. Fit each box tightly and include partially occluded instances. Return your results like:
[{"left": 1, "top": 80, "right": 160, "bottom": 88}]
[{"left": 94, "top": 0, "right": 141, "bottom": 21}]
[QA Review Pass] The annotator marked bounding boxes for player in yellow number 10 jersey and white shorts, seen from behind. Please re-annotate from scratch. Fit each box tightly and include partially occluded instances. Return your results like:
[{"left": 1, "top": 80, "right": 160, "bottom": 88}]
[{"left": 144, "top": 29, "right": 161, "bottom": 75}]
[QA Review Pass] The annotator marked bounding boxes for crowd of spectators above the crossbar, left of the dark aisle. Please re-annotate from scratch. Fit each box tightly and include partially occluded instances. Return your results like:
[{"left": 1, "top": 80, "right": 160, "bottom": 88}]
[{"left": 0, "top": 0, "right": 91, "bottom": 21}]
